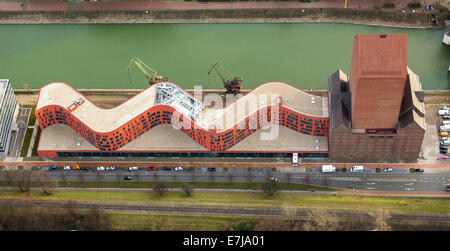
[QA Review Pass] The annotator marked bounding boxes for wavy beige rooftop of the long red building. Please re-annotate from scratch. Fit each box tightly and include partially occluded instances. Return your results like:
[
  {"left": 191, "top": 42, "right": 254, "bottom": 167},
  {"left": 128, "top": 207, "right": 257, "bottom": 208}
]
[{"left": 36, "top": 82, "right": 329, "bottom": 133}]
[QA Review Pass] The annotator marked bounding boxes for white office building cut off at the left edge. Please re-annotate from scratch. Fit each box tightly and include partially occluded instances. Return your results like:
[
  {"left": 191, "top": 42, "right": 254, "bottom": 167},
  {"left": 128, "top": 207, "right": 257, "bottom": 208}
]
[{"left": 0, "top": 79, "right": 19, "bottom": 157}]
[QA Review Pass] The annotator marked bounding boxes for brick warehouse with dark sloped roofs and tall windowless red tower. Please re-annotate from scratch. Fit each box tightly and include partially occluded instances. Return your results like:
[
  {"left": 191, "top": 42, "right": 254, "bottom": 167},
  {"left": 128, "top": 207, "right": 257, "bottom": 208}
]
[{"left": 328, "top": 34, "right": 425, "bottom": 160}]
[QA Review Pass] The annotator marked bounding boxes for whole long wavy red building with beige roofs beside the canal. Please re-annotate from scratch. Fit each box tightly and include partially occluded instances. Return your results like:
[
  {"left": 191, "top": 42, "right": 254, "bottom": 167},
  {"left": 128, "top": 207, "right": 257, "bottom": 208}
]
[{"left": 36, "top": 82, "right": 329, "bottom": 157}]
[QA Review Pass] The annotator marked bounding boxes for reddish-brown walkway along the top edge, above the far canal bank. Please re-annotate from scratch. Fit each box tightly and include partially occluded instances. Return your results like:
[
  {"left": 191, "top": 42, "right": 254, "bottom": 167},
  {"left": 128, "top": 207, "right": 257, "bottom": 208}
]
[{"left": 0, "top": 0, "right": 435, "bottom": 13}]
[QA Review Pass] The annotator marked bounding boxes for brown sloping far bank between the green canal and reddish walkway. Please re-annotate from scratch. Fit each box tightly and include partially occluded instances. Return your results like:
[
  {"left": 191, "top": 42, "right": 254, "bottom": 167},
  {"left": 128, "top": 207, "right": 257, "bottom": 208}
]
[{"left": 0, "top": 8, "right": 448, "bottom": 28}]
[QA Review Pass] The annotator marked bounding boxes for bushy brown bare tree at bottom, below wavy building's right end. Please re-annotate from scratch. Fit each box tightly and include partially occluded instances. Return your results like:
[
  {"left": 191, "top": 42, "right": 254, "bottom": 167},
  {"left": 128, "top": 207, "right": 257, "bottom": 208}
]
[{"left": 303, "top": 208, "right": 339, "bottom": 231}]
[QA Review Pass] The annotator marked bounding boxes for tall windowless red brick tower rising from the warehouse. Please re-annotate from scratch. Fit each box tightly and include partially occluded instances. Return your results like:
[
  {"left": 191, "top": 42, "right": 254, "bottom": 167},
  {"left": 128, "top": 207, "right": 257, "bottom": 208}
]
[{"left": 350, "top": 34, "right": 408, "bottom": 129}]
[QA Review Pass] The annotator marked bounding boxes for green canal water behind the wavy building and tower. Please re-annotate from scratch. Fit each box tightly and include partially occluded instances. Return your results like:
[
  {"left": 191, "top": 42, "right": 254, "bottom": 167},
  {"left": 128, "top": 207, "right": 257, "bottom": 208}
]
[{"left": 0, "top": 23, "right": 450, "bottom": 89}]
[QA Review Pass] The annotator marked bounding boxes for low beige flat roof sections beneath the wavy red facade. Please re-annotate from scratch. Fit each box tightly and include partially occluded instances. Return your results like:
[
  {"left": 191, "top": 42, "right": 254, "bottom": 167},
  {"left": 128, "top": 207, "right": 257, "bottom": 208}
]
[{"left": 38, "top": 124, "right": 328, "bottom": 152}]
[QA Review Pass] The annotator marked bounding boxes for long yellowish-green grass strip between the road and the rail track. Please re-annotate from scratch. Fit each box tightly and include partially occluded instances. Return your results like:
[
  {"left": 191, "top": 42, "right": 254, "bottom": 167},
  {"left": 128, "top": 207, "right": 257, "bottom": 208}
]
[{"left": 0, "top": 190, "right": 450, "bottom": 214}]
